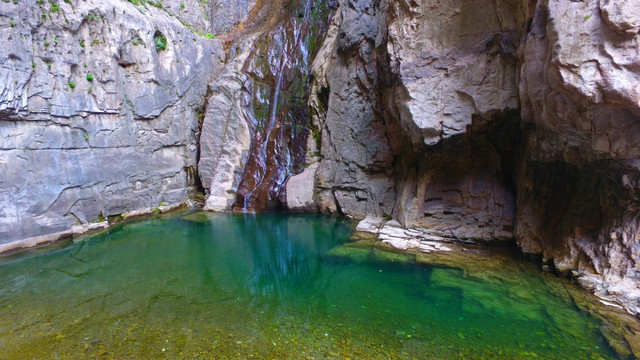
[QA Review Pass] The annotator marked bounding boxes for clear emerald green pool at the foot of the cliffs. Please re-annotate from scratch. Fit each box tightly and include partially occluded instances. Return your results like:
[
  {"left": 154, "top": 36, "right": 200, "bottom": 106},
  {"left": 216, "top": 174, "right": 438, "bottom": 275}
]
[{"left": 0, "top": 213, "right": 616, "bottom": 359}]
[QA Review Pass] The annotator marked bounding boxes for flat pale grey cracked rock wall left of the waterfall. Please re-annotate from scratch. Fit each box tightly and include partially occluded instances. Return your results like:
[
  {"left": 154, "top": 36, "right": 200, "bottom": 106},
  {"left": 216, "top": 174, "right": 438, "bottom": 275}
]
[{"left": 0, "top": 0, "right": 224, "bottom": 243}]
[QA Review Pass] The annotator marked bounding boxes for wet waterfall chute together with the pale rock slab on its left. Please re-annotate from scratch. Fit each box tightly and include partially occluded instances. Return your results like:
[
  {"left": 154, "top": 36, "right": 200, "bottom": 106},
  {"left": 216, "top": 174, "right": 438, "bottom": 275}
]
[{"left": 199, "top": 0, "right": 332, "bottom": 211}]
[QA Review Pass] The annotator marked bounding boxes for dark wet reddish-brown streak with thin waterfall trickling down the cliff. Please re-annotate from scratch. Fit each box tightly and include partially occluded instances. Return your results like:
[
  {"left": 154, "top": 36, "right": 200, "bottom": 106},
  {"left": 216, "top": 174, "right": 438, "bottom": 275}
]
[{"left": 234, "top": 0, "right": 335, "bottom": 212}]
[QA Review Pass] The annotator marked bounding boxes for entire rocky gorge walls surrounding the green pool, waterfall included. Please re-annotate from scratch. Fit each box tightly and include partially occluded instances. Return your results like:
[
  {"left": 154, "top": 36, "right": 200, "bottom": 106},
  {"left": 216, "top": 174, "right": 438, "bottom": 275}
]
[{"left": 0, "top": 0, "right": 640, "bottom": 326}]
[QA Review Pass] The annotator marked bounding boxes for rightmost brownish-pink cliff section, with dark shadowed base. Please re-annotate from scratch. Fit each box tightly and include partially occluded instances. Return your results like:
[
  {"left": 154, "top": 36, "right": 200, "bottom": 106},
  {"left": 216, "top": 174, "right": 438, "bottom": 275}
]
[{"left": 516, "top": 0, "right": 640, "bottom": 313}]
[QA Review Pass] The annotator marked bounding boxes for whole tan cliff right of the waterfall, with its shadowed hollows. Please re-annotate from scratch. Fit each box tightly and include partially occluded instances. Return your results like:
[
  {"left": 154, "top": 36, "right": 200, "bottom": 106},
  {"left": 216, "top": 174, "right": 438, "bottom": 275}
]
[{"left": 300, "top": 0, "right": 640, "bottom": 314}]
